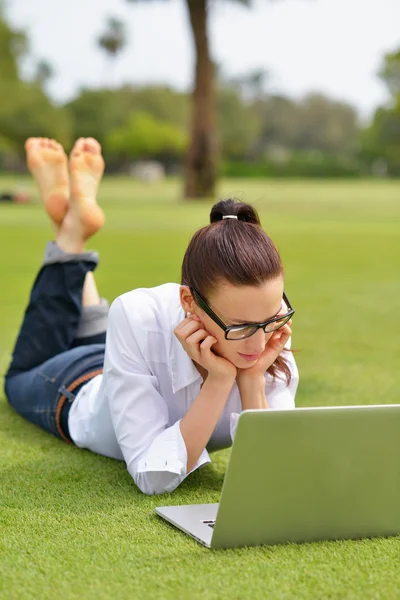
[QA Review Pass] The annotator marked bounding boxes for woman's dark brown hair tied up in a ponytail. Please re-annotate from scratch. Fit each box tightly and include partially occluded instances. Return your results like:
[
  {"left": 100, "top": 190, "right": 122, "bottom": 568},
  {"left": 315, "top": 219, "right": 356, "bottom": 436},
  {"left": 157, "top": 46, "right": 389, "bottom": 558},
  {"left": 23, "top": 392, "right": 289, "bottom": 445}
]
[{"left": 181, "top": 199, "right": 291, "bottom": 385}]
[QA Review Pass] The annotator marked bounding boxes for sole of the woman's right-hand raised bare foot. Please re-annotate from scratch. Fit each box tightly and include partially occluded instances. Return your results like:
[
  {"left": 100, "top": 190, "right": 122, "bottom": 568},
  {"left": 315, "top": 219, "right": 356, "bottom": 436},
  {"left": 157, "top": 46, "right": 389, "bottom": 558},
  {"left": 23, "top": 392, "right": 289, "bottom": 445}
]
[{"left": 67, "top": 138, "right": 105, "bottom": 241}]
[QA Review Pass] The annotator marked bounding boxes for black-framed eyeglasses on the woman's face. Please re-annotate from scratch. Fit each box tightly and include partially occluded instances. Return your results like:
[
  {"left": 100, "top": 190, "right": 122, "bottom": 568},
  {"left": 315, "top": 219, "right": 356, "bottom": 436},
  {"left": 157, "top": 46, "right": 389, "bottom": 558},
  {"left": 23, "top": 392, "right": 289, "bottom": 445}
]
[{"left": 189, "top": 286, "right": 295, "bottom": 341}]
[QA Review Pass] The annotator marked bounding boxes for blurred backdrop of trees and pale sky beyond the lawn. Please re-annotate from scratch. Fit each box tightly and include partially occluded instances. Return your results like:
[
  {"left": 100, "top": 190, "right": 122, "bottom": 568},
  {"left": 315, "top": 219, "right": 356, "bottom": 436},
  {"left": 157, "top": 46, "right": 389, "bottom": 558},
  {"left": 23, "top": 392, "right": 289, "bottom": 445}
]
[{"left": 0, "top": 0, "right": 400, "bottom": 198}]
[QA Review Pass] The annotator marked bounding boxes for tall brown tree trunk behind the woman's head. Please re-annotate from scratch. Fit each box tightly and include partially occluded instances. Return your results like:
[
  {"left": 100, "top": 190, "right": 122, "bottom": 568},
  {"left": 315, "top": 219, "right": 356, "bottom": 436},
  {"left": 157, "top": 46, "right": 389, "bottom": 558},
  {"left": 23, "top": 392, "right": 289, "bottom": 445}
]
[{"left": 185, "top": 0, "right": 218, "bottom": 199}]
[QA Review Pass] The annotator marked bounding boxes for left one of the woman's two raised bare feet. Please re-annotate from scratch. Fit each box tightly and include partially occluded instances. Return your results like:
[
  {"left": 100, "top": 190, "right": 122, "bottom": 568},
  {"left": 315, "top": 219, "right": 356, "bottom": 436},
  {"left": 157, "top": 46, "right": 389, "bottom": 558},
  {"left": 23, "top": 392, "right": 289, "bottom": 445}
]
[{"left": 25, "top": 138, "right": 69, "bottom": 230}]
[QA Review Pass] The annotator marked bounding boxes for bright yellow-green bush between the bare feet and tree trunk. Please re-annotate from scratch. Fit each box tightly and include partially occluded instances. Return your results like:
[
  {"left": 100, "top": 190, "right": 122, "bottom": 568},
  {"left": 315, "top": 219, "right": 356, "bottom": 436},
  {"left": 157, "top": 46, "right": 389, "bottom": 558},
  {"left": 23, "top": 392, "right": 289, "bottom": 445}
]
[{"left": 105, "top": 112, "right": 187, "bottom": 159}]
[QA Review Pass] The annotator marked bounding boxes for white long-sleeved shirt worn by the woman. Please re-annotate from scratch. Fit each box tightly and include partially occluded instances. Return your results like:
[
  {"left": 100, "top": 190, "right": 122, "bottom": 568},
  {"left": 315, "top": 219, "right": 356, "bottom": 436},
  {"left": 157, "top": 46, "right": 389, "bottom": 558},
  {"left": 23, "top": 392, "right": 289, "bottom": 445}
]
[{"left": 69, "top": 283, "right": 298, "bottom": 494}]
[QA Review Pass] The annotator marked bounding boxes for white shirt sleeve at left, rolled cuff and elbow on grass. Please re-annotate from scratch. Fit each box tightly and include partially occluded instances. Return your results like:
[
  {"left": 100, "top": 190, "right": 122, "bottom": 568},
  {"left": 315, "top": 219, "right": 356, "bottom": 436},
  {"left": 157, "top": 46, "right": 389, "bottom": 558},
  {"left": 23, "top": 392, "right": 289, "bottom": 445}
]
[{"left": 104, "top": 298, "right": 211, "bottom": 494}]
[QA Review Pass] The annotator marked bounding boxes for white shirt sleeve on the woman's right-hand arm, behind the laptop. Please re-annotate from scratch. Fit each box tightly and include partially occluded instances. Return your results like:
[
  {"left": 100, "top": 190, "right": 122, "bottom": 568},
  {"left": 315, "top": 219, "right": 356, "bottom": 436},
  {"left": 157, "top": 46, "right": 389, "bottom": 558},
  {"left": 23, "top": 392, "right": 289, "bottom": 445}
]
[{"left": 230, "top": 338, "right": 299, "bottom": 442}]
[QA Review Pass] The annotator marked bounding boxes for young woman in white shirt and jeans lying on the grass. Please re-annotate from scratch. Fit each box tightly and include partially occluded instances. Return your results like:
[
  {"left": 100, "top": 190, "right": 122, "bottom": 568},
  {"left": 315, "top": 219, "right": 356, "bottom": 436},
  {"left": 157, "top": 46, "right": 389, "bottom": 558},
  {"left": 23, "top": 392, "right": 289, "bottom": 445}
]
[{"left": 5, "top": 138, "right": 298, "bottom": 494}]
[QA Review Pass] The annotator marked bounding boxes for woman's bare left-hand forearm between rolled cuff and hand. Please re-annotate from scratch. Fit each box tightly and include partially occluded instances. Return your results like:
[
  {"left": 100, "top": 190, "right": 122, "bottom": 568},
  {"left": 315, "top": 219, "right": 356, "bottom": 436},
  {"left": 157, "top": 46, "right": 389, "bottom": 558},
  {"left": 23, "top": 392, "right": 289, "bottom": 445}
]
[{"left": 180, "top": 377, "right": 234, "bottom": 472}]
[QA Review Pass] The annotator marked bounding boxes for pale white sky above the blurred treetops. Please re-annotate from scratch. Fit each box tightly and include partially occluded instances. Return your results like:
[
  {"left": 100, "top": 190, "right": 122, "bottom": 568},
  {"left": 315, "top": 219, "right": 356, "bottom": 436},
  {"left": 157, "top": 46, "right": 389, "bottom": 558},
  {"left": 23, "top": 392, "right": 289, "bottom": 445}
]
[{"left": 5, "top": 0, "right": 400, "bottom": 118}]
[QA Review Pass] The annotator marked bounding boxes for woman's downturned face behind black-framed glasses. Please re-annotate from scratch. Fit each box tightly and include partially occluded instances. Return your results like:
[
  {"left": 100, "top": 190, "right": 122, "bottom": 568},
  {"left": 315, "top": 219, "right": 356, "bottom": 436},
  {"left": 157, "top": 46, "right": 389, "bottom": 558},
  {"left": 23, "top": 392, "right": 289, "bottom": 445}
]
[{"left": 191, "top": 277, "right": 286, "bottom": 369}]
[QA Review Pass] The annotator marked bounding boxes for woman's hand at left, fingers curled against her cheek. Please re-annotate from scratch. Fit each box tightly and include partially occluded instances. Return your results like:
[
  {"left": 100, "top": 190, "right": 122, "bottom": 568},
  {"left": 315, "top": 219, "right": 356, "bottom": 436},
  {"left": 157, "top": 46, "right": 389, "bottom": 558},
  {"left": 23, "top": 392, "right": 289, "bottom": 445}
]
[{"left": 174, "top": 315, "right": 237, "bottom": 381}]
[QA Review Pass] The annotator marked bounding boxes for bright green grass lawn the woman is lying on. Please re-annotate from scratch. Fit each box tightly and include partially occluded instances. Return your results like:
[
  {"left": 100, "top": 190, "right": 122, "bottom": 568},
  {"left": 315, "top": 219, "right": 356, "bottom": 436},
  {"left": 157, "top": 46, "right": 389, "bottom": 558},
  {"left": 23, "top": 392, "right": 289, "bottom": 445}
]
[{"left": 0, "top": 178, "right": 400, "bottom": 600}]
